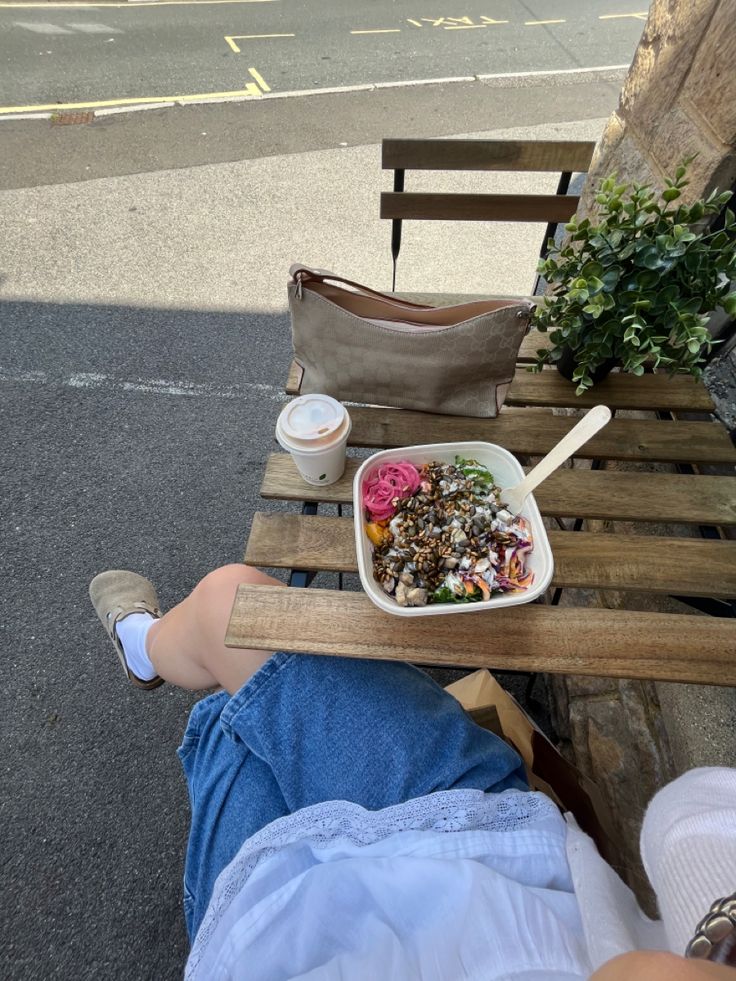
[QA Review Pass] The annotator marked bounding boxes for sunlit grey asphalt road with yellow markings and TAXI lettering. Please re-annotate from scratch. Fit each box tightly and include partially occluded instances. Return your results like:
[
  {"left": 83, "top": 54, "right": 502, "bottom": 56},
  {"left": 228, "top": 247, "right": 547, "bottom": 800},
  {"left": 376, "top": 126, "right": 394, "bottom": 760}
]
[{"left": 0, "top": 0, "right": 646, "bottom": 113}]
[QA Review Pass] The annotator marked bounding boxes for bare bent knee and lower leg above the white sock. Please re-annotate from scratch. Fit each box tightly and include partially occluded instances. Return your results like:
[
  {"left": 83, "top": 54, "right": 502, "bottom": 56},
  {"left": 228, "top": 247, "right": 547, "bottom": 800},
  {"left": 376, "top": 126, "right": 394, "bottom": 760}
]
[{"left": 146, "top": 565, "right": 284, "bottom": 695}]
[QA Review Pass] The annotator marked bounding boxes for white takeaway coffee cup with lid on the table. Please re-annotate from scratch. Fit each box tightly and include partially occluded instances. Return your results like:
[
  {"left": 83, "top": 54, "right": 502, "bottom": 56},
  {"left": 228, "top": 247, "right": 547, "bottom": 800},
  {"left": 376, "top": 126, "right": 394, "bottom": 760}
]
[{"left": 276, "top": 395, "right": 352, "bottom": 484}]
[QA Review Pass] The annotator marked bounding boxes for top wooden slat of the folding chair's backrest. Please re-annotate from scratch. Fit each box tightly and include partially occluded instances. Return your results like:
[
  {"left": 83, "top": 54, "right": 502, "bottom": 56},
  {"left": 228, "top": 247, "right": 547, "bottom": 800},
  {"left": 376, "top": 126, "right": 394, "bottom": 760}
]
[{"left": 381, "top": 139, "right": 595, "bottom": 173}]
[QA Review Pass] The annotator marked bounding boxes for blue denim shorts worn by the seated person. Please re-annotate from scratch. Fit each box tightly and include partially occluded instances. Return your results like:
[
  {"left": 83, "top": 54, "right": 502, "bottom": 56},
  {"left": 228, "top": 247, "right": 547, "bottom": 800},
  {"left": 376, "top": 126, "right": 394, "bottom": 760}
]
[{"left": 179, "top": 653, "right": 528, "bottom": 939}]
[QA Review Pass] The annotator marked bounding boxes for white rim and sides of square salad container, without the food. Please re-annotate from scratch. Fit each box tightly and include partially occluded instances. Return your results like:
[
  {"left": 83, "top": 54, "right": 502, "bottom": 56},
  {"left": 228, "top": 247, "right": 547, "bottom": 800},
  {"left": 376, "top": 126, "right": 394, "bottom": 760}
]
[{"left": 353, "top": 442, "right": 554, "bottom": 617}]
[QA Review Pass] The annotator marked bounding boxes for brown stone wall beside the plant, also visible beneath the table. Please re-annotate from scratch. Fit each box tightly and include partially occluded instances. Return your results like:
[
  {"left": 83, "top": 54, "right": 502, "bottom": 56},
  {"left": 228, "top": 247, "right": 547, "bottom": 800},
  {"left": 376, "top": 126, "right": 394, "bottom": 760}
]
[{"left": 548, "top": 0, "right": 736, "bottom": 912}]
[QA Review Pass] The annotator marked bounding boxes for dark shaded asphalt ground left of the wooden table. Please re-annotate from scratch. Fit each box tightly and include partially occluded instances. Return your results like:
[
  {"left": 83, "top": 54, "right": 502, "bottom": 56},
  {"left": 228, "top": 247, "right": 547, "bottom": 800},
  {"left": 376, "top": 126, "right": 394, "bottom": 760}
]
[{"left": 0, "top": 301, "right": 300, "bottom": 981}]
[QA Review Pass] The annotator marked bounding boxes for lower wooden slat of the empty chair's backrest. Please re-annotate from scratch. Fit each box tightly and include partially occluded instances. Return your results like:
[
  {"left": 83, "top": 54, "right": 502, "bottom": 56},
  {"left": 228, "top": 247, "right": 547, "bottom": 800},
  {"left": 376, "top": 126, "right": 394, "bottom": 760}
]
[{"left": 381, "top": 191, "right": 580, "bottom": 223}]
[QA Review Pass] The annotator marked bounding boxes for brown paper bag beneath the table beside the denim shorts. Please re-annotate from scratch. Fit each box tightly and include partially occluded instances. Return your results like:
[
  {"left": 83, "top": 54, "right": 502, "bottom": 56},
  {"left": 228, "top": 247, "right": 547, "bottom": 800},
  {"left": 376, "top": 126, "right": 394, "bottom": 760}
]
[{"left": 446, "top": 670, "right": 617, "bottom": 862}]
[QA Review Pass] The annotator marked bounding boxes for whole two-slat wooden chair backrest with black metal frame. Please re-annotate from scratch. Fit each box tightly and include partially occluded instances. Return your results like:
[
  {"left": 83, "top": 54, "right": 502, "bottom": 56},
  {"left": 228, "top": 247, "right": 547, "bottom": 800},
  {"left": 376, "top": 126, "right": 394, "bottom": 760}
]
[{"left": 381, "top": 139, "right": 595, "bottom": 290}]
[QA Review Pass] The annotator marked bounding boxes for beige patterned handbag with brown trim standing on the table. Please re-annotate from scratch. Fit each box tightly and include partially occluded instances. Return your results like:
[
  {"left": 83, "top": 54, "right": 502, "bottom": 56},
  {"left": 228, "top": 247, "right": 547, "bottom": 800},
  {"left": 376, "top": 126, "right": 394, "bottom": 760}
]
[{"left": 288, "top": 265, "right": 534, "bottom": 416}]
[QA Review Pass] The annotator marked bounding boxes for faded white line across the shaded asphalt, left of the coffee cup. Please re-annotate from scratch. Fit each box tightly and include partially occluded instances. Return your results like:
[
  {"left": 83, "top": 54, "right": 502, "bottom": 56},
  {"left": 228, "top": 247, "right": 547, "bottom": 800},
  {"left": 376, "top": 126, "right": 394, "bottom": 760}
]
[{"left": 0, "top": 367, "right": 289, "bottom": 402}]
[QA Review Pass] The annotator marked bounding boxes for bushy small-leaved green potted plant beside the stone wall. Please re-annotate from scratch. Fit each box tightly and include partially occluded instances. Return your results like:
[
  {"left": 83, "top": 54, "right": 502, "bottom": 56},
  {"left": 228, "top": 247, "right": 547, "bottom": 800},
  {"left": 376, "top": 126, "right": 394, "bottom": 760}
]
[{"left": 530, "top": 158, "right": 736, "bottom": 395}]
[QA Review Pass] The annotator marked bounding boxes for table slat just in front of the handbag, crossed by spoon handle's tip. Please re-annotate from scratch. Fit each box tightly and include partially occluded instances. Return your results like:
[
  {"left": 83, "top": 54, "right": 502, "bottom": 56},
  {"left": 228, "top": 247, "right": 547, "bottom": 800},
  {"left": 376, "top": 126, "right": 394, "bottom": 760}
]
[{"left": 349, "top": 406, "right": 736, "bottom": 465}]
